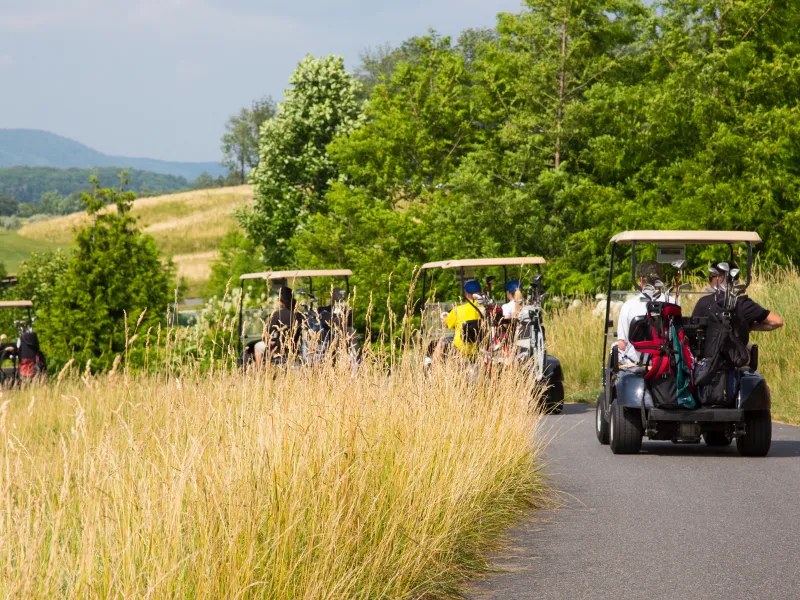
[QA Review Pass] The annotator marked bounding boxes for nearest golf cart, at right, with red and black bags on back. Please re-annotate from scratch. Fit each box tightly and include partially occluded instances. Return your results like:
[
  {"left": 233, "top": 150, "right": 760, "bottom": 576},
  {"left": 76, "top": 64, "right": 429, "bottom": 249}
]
[{"left": 595, "top": 231, "right": 772, "bottom": 456}]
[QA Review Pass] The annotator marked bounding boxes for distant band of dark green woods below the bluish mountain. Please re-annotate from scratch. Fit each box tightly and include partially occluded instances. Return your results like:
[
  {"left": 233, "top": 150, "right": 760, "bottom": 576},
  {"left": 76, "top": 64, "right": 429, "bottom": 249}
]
[{"left": 0, "top": 167, "right": 189, "bottom": 207}]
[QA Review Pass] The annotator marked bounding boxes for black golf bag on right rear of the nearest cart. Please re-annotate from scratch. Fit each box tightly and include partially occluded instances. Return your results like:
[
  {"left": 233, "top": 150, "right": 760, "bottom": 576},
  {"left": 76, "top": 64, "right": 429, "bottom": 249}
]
[{"left": 694, "top": 302, "right": 750, "bottom": 406}]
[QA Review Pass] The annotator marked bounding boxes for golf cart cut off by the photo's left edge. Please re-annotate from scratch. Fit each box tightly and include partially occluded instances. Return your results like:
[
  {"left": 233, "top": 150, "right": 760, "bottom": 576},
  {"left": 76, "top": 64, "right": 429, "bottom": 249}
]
[{"left": 0, "top": 300, "right": 47, "bottom": 387}]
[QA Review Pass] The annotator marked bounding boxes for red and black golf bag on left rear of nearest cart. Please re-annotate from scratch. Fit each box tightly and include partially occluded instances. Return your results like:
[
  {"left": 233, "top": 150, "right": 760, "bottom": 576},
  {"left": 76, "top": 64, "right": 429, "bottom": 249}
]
[{"left": 629, "top": 302, "right": 695, "bottom": 409}]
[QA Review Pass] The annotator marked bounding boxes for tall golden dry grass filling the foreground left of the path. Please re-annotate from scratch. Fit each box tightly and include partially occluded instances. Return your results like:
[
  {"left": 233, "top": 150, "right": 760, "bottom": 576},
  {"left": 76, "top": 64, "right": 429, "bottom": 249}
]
[{"left": 0, "top": 354, "right": 542, "bottom": 599}]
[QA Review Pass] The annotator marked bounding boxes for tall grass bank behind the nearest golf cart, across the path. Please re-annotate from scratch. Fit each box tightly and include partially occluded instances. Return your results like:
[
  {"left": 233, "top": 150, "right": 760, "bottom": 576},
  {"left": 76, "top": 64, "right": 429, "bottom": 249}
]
[{"left": 546, "top": 267, "right": 800, "bottom": 425}]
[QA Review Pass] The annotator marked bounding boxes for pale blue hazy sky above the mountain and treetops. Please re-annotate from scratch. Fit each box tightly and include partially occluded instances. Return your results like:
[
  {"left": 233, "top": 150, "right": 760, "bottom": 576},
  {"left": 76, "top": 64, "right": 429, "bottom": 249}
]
[{"left": 0, "top": 0, "right": 521, "bottom": 161}]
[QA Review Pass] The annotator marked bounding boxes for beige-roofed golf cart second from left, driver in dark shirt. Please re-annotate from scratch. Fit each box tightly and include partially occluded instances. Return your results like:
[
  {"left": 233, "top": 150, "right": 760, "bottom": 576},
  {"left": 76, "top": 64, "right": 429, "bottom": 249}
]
[{"left": 238, "top": 269, "right": 359, "bottom": 369}]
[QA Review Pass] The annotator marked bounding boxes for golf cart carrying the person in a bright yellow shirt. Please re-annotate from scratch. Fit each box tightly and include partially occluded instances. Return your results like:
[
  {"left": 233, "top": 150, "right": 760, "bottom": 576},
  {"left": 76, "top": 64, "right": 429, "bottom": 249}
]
[{"left": 421, "top": 257, "right": 564, "bottom": 413}]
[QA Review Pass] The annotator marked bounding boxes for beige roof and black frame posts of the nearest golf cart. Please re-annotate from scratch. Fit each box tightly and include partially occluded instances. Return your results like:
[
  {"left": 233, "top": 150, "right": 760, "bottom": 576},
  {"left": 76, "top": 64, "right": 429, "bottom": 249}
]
[{"left": 603, "top": 230, "right": 761, "bottom": 370}]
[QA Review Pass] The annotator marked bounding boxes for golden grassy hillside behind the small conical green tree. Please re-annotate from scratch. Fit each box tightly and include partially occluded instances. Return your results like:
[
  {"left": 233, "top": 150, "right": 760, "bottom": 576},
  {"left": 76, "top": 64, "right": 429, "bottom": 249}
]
[{"left": 18, "top": 185, "right": 253, "bottom": 287}]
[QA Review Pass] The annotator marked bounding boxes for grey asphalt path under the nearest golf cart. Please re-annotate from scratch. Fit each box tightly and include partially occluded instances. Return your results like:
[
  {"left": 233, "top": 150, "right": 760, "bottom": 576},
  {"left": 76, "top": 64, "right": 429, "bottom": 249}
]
[{"left": 469, "top": 405, "right": 800, "bottom": 600}]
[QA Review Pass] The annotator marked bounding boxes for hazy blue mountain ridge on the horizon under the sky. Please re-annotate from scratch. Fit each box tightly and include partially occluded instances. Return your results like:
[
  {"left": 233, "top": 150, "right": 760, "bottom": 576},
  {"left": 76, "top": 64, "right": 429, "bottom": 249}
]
[{"left": 0, "top": 129, "right": 226, "bottom": 181}]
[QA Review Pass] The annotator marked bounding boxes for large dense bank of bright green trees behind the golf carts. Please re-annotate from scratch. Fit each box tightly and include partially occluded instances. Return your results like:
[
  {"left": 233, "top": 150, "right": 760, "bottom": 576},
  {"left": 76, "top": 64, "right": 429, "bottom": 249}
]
[{"left": 249, "top": 0, "right": 800, "bottom": 319}]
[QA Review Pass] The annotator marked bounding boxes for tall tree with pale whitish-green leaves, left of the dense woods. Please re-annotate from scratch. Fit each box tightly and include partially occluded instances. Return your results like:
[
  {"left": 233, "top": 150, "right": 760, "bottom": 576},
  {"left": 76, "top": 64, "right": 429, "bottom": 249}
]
[{"left": 239, "top": 56, "right": 361, "bottom": 267}]
